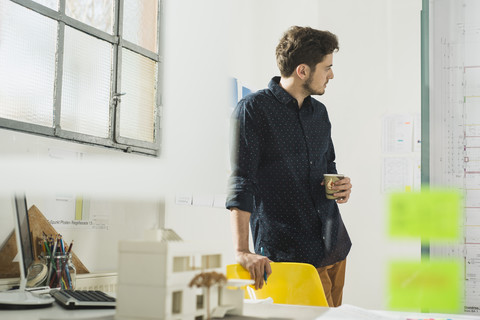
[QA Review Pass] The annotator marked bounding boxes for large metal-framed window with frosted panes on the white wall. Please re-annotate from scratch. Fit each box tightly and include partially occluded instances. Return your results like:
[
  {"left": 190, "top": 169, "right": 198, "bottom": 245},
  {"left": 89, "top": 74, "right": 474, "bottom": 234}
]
[{"left": 0, "top": 0, "right": 161, "bottom": 155}]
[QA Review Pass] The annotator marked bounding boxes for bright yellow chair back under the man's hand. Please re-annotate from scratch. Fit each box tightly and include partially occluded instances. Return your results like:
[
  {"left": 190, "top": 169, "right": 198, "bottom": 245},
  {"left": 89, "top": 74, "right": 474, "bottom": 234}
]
[{"left": 227, "top": 262, "right": 328, "bottom": 307}]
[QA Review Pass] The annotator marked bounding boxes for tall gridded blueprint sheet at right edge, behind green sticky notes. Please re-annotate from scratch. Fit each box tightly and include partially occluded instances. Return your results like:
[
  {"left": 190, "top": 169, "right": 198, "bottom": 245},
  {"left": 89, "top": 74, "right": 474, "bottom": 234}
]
[{"left": 430, "top": 0, "right": 480, "bottom": 313}]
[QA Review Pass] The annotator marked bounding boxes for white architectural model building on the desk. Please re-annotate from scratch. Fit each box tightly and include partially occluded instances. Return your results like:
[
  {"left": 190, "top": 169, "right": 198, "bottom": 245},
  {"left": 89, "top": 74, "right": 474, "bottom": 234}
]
[{"left": 115, "top": 230, "right": 245, "bottom": 320}]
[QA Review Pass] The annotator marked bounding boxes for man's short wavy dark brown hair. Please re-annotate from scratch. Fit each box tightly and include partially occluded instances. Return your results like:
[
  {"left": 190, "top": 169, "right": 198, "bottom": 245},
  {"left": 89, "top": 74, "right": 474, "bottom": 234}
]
[{"left": 276, "top": 26, "right": 338, "bottom": 77}]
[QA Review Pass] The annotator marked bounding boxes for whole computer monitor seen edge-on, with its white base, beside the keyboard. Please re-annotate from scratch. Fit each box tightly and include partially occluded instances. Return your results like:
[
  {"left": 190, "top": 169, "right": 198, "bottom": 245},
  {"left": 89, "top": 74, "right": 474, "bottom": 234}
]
[{"left": 0, "top": 195, "right": 54, "bottom": 309}]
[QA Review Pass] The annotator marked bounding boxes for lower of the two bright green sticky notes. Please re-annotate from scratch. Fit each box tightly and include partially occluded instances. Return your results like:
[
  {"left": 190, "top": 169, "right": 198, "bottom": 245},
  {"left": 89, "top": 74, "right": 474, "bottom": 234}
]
[{"left": 388, "top": 260, "right": 463, "bottom": 313}]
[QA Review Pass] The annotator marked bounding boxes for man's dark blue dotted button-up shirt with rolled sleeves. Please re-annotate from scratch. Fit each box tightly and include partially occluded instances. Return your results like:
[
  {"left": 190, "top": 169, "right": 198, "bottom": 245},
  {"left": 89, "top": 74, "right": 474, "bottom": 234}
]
[{"left": 226, "top": 77, "right": 351, "bottom": 268}]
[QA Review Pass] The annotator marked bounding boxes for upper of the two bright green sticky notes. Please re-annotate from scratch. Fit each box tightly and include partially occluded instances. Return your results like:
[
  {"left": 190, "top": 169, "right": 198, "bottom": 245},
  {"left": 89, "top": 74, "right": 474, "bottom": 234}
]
[{"left": 388, "top": 190, "right": 462, "bottom": 240}]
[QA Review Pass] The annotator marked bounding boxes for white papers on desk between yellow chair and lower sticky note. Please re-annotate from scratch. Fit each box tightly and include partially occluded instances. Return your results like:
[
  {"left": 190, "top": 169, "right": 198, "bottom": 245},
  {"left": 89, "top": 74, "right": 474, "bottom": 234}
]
[{"left": 317, "top": 304, "right": 405, "bottom": 320}]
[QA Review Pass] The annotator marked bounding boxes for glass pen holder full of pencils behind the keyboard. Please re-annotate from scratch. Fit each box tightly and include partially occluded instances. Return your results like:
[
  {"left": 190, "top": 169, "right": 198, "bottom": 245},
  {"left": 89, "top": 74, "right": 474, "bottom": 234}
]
[{"left": 40, "top": 252, "right": 77, "bottom": 290}]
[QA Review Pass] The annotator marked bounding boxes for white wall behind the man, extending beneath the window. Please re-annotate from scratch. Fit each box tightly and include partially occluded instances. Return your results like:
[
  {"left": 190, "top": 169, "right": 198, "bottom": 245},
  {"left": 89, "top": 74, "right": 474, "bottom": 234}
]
[{"left": 0, "top": 0, "right": 421, "bottom": 309}]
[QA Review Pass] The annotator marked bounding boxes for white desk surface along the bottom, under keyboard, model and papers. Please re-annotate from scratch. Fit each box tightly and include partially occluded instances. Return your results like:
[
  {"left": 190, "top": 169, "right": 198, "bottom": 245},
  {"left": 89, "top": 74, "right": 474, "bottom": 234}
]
[{"left": 0, "top": 303, "right": 480, "bottom": 320}]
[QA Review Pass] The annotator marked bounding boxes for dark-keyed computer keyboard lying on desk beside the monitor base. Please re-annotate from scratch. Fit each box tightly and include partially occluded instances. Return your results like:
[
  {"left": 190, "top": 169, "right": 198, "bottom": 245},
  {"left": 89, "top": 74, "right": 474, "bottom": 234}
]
[{"left": 50, "top": 290, "right": 116, "bottom": 309}]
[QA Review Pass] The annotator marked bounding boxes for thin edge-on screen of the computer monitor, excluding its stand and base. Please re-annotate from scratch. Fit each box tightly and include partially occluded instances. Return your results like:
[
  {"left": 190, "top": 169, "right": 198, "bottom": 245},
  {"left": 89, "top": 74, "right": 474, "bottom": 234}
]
[{"left": 15, "top": 195, "right": 34, "bottom": 277}]
